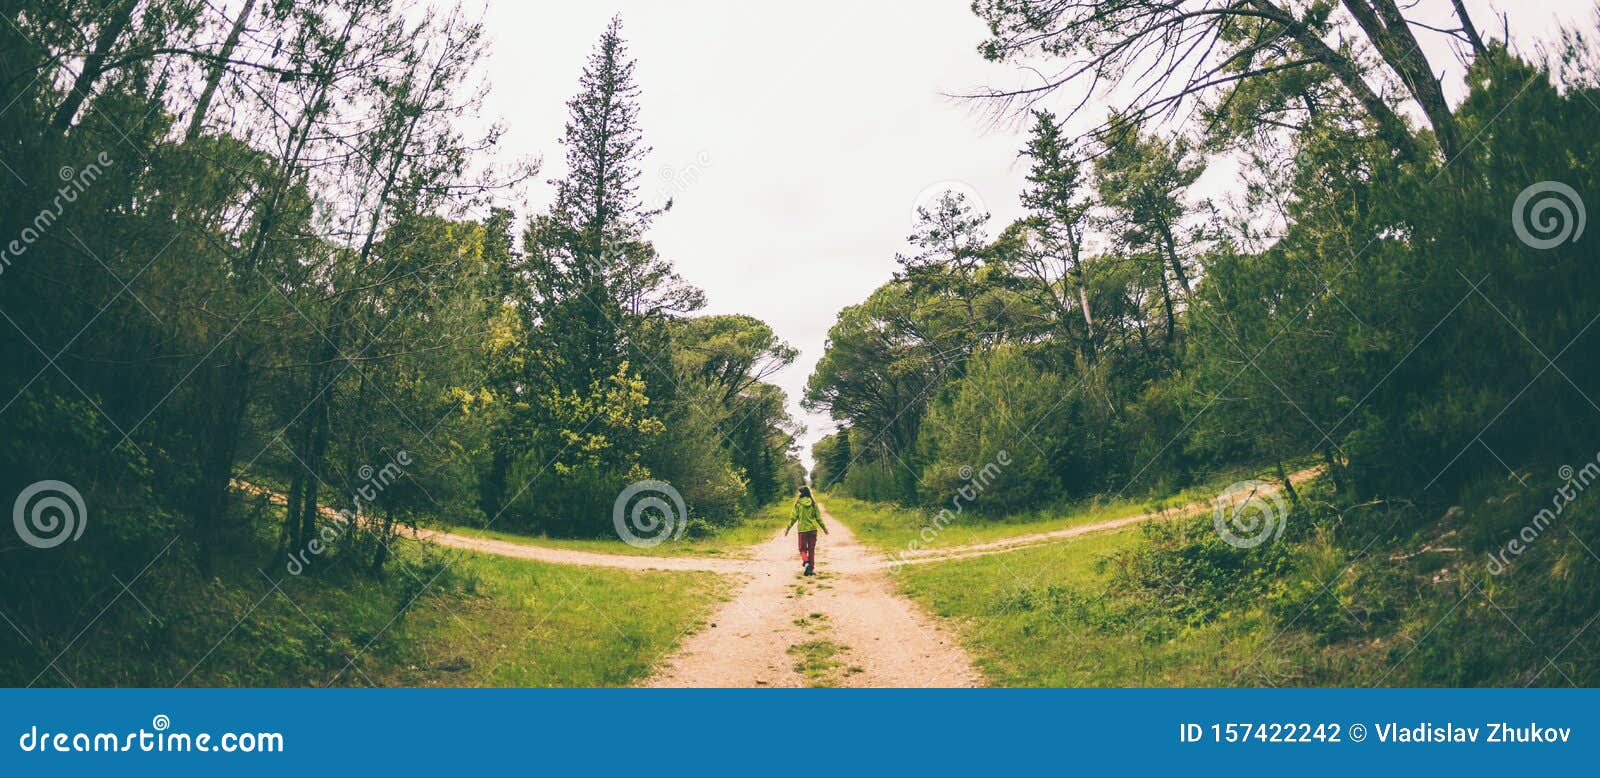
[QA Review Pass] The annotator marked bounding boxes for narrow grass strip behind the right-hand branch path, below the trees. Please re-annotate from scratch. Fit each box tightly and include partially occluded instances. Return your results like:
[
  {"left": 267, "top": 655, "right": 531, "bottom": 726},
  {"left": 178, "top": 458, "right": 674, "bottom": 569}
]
[{"left": 821, "top": 463, "right": 1307, "bottom": 554}]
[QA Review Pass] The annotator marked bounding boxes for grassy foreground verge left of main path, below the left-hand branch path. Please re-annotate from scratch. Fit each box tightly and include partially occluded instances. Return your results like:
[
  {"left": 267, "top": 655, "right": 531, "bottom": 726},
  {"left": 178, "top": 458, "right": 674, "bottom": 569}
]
[{"left": 10, "top": 543, "right": 726, "bottom": 687}]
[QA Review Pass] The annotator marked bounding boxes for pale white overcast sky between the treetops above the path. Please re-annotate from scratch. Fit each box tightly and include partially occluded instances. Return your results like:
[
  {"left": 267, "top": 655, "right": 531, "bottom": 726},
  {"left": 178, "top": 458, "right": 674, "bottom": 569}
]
[{"left": 467, "top": 0, "right": 1595, "bottom": 463}]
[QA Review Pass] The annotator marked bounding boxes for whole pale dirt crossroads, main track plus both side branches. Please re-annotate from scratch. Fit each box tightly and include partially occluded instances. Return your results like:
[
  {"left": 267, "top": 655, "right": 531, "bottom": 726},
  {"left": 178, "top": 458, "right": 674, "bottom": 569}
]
[{"left": 235, "top": 467, "right": 1320, "bottom": 687}]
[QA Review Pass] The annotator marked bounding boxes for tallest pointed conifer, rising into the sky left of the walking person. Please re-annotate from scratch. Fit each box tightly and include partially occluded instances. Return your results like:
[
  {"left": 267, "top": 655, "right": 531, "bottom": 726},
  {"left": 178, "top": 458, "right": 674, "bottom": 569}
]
[{"left": 523, "top": 18, "right": 704, "bottom": 533}]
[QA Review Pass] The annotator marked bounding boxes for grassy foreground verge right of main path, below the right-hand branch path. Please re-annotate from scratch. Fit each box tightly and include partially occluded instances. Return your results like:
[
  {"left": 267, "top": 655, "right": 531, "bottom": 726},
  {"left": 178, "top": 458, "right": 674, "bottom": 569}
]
[{"left": 835, "top": 467, "right": 1600, "bottom": 687}]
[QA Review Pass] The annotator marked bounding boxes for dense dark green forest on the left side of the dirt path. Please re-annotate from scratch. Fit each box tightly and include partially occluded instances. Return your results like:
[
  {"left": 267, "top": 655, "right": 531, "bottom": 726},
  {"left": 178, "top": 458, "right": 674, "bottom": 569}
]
[{"left": 0, "top": 0, "right": 803, "bottom": 685}]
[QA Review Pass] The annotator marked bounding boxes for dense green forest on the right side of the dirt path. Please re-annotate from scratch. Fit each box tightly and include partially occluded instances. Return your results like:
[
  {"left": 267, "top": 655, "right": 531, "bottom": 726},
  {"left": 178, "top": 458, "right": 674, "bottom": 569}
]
[{"left": 805, "top": 0, "right": 1600, "bottom": 684}]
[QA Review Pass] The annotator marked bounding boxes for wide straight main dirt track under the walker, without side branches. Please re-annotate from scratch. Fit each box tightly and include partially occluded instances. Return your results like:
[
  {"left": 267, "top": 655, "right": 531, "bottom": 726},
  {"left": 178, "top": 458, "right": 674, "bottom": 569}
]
[{"left": 645, "top": 509, "right": 982, "bottom": 687}]
